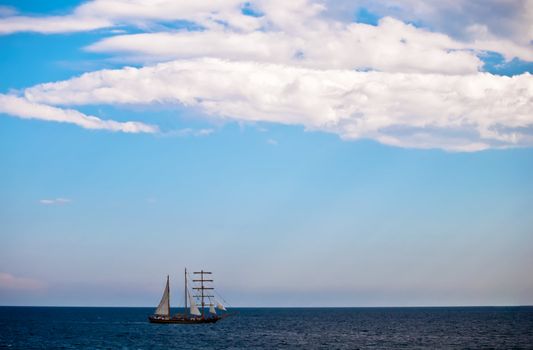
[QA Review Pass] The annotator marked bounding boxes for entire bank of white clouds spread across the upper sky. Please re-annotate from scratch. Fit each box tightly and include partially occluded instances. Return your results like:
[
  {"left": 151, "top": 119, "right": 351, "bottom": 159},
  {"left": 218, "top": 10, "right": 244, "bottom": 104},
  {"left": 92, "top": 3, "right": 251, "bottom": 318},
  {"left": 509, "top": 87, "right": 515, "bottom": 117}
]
[{"left": 0, "top": 0, "right": 533, "bottom": 151}]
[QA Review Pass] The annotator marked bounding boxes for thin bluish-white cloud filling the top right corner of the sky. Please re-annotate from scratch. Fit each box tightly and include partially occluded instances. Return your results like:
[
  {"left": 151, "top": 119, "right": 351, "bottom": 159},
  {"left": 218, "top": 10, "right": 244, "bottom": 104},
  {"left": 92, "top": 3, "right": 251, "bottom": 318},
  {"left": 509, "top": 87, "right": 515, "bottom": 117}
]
[{"left": 326, "top": 0, "right": 533, "bottom": 61}]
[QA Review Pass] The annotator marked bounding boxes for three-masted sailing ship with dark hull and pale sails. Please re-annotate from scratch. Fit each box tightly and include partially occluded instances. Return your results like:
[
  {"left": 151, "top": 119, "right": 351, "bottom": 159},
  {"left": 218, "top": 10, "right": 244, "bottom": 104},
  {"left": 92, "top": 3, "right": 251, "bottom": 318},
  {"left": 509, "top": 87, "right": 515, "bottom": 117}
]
[{"left": 148, "top": 269, "right": 228, "bottom": 324}]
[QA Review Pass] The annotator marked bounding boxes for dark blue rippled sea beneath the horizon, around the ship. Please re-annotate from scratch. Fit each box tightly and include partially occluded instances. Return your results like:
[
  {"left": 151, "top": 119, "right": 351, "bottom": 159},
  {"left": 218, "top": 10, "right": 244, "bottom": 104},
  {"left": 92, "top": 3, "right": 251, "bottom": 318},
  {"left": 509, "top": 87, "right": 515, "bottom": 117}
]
[{"left": 0, "top": 307, "right": 533, "bottom": 349}]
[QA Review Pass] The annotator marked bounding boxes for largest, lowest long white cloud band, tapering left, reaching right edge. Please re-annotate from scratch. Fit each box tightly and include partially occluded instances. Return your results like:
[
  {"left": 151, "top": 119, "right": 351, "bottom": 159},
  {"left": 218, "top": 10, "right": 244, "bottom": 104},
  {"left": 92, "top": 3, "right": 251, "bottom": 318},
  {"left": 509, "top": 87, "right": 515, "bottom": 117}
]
[{"left": 20, "top": 59, "right": 533, "bottom": 151}]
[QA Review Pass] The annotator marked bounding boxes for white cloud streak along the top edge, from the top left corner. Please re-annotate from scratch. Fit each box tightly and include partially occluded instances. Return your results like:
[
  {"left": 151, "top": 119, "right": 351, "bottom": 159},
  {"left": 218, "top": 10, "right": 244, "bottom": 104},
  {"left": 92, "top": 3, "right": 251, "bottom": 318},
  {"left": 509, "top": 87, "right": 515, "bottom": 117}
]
[{"left": 0, "top": 0, "right": 260, "bottom": 34}]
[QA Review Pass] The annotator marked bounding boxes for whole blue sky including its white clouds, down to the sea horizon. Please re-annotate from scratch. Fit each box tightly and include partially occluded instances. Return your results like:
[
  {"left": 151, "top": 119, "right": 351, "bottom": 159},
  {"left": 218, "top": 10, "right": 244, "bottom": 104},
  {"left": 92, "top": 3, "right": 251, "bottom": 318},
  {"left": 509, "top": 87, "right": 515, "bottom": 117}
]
[{"left": 0, "top": 1, "right": 533, "bottom": 306}]
